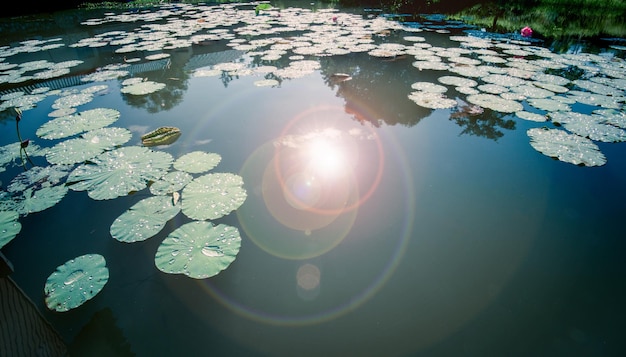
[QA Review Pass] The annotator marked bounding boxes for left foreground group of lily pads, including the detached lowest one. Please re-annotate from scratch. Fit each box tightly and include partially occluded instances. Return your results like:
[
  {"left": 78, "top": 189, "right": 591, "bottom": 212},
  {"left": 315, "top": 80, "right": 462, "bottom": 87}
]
[{"left": 0, "top": 103, "right": 246, "bottom": 311}]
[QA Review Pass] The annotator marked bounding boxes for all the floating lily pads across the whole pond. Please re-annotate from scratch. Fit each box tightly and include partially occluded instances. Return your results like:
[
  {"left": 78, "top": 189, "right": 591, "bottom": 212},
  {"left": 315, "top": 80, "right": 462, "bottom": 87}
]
[{"left": 0, "top": 3, "right": 626, "bottom": 311}]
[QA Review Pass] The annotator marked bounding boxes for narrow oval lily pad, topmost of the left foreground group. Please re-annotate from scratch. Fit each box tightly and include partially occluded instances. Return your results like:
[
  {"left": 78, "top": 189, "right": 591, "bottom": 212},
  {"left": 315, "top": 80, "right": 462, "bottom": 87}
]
[{"left": 36, "top": 108, "right": 120, "bottom": 139}]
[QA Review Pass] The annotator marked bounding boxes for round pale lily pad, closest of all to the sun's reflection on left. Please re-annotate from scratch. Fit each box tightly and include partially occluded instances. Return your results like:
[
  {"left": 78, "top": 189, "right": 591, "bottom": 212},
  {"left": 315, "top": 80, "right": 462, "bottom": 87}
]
[{"left": 182, "top": 173, "right": 247, "bottom": 220}]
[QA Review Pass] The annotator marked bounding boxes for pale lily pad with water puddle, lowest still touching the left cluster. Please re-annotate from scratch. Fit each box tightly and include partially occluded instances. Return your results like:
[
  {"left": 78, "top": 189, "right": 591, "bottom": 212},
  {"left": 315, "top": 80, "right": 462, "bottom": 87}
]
[{"left": 154, "top": 221, "right": 241, "bottom": 279}]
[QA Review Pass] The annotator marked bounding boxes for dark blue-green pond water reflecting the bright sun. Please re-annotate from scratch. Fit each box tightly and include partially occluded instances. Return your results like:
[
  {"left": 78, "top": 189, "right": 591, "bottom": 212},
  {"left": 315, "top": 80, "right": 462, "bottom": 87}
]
[{"left": 0, "top": 2, "right": 626, "bottom": 356}]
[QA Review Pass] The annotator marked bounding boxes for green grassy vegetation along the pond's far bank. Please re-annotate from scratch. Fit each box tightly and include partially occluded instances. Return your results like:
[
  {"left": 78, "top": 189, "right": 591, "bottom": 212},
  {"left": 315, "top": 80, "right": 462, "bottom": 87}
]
[{"left": 81, "top": 0, "right": 626, "bottom": 38}]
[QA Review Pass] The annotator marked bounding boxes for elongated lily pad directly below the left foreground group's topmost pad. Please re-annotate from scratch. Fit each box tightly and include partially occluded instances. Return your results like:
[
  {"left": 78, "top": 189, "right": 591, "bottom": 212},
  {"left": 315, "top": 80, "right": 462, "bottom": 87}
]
[{"left": 46, "top": 128, "right": 132, "bottom": 165}]
